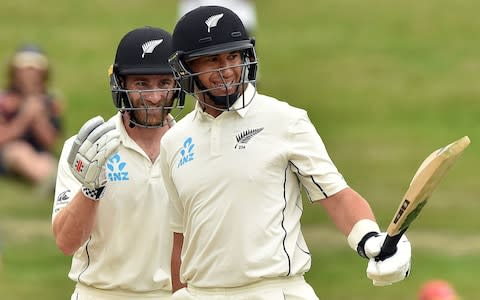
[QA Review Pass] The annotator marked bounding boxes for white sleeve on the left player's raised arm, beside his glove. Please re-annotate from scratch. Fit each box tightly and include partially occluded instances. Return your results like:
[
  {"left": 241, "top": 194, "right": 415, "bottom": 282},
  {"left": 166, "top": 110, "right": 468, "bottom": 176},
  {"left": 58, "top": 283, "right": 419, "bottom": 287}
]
[{"left": 52, "top": 136, "right": 81, "bottom": 223}]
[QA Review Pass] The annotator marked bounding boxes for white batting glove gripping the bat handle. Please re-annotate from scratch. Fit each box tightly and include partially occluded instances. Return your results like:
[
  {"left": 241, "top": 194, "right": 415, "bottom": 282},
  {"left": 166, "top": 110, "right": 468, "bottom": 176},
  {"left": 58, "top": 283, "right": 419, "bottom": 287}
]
[{"left": 364, "top": 232, "right": 412, "bottom": 286}]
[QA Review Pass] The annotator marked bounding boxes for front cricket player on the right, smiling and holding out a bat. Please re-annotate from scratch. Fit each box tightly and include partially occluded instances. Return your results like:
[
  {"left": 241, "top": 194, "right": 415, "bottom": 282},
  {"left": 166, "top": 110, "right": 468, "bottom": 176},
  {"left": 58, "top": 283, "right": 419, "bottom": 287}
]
[{"left": 160, "top": 6, "right": 411, "bottom": 300}]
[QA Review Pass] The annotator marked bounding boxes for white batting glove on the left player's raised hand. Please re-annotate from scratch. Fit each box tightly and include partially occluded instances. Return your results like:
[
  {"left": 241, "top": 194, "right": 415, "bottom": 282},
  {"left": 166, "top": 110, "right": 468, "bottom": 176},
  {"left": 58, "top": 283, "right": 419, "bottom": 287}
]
[{"left": 67, "top": 116, "right": 120, "bottom": 190}]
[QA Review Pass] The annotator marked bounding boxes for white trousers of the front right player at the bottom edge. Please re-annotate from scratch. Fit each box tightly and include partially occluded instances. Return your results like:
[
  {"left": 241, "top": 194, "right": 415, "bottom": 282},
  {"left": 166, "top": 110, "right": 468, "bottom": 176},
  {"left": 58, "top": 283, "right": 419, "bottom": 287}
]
[{"left": 172, "top": 276, "right": 319, "bottom": 300}]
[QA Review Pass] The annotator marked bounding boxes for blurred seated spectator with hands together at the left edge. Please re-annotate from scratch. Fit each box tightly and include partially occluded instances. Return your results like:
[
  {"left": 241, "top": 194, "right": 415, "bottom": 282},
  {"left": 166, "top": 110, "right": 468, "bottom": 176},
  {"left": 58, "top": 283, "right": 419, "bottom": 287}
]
[{"left": 0, "top": 45, "right": 61, "bottom": 186}]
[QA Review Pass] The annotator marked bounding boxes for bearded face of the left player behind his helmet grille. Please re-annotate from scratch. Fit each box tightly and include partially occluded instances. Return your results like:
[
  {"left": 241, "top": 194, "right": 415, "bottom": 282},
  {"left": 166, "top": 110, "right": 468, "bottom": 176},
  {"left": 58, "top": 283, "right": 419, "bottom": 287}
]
[{"left": 125, "top": 75, "right": 175, "bottom": 126}]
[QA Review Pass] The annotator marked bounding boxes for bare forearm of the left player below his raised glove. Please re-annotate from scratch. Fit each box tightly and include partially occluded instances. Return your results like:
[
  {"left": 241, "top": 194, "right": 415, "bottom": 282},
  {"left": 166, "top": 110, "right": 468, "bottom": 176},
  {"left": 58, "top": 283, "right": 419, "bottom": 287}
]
[{"left": 53, "top": 192, "right": 99, "bottom": 255}]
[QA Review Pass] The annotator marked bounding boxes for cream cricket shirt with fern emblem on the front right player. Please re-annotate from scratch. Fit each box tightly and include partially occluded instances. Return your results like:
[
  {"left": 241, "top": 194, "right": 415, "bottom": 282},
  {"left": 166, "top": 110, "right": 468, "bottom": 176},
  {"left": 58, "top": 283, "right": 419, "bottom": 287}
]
[{"left": 160, "top": 85, "right": 347, "bottom": 288}]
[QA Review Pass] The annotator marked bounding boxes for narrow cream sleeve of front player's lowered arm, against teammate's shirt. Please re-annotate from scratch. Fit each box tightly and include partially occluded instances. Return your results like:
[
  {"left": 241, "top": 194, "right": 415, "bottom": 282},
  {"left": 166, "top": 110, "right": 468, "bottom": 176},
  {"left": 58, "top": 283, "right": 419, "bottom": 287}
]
[{"left": 160, "top": 144, "right": 184, "bottom": 233}]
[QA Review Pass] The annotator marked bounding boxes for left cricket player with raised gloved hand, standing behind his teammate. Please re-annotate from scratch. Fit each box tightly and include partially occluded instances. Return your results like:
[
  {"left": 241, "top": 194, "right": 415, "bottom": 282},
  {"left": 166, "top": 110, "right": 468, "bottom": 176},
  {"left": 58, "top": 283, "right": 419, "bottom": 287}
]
[{"left": 52, "top": 27, "right": 183, "bottom": 300}]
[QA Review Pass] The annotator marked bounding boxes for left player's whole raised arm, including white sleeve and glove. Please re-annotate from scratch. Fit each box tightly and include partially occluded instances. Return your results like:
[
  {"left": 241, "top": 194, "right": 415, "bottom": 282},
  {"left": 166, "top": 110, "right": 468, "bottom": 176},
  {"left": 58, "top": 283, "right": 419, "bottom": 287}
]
[{"left": 52, "top": 117, "right": 120, "bottom": 255}]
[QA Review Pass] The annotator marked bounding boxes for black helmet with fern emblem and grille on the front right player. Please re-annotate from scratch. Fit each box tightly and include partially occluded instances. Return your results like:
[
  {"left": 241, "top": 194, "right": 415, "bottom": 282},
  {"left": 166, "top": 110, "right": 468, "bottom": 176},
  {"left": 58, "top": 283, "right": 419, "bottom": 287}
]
[{"left": 169, "top": 6, "right": 257, "bottom": 110}]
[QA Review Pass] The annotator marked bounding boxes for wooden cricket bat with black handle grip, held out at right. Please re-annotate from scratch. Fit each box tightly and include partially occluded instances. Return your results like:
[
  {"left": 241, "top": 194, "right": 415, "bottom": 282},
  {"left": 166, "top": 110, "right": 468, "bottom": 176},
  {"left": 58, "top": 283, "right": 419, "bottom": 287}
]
[{"left": 375, "top": 136, "right": 470, "bottom": 261}]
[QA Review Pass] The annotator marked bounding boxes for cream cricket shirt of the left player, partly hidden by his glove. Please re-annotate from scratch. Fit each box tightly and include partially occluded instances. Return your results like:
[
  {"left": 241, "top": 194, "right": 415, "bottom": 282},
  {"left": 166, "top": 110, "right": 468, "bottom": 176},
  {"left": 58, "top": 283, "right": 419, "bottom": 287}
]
[{"left": 52, "top": 113, "right": 173, "bottom": 292}]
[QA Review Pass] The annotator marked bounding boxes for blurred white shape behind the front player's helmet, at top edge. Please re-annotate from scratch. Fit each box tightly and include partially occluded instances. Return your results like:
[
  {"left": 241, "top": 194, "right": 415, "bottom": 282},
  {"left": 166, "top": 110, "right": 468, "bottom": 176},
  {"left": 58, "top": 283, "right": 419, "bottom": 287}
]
[{"left": 178, "top": 0, "right": 257, "bottom": 36}]
